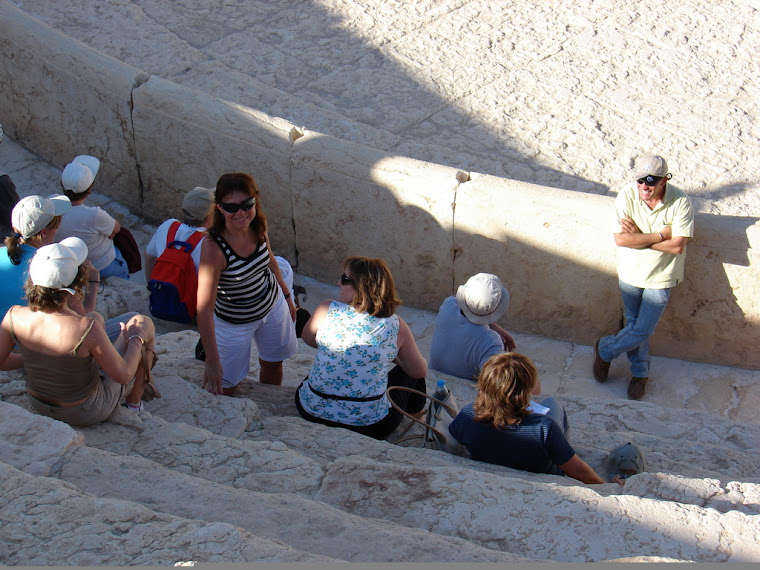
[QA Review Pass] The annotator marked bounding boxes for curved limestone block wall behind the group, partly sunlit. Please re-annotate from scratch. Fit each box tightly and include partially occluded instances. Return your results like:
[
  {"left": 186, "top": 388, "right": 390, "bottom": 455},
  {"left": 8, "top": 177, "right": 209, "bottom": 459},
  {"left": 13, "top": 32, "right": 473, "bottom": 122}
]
[{"left": 0, "top": 0, "right": 760, "bottom": 368}]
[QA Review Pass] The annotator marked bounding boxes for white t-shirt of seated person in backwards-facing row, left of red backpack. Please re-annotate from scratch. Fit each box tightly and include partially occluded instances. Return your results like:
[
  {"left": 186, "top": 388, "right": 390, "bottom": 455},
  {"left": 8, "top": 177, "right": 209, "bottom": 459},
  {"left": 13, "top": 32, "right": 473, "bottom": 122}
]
[{"left": 55, "top": 205, "right": 116, "bottom": 271}]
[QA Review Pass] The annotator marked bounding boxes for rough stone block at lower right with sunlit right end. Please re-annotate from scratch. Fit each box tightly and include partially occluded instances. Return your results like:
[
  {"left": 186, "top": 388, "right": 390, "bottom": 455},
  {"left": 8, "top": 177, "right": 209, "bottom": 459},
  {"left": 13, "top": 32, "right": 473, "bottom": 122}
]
[{"left": 315, "top": 450, "right": 760, "bottom": 562}]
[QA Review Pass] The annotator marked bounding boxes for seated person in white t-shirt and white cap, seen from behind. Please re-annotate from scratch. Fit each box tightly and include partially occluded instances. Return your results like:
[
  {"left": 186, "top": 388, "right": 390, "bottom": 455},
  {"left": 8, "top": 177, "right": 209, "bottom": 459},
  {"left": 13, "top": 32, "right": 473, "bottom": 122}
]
[{"left": 58, "top": 154, "right": 129, "bottom": 279}]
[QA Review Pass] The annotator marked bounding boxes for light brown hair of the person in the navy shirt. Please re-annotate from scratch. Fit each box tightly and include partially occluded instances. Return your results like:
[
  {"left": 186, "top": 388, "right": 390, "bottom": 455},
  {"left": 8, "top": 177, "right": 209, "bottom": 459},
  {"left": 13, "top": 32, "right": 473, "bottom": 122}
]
[{"left": 473, "top": 352, "right": 538, "bottom": 429}]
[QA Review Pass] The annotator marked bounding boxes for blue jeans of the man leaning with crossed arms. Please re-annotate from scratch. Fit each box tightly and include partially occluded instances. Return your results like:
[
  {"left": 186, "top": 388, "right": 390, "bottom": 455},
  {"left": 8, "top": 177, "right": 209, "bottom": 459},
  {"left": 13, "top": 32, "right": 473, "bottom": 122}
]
[{"left": 599, "top": 281, "right": 671, "bottom": 378}]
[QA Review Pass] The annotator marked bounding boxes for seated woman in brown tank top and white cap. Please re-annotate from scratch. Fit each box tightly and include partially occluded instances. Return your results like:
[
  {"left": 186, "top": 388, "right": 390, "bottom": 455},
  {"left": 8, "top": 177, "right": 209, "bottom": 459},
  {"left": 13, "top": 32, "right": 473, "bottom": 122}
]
[{"left": 0, "top": 238, "right": 160, "bottom": 426}]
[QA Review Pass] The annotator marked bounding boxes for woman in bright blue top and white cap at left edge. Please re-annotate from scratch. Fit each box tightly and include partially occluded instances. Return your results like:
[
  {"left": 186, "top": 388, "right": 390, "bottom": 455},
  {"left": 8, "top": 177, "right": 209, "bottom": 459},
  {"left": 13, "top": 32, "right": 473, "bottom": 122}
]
[{"left": 0, "top": 195, "right": 71, "bottom": 315}]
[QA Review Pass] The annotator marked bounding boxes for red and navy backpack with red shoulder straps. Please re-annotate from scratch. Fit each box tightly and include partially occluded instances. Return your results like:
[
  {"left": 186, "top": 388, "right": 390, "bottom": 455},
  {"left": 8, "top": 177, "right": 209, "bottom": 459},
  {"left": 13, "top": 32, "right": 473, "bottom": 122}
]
[{"left": 148, "top": 221, "right": 205, "bottom": 323}]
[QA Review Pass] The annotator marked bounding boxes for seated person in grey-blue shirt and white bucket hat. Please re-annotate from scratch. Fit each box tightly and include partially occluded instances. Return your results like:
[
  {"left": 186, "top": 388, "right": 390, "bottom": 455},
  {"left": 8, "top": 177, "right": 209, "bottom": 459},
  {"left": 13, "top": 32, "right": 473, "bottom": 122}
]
[{"left": 430, "top": 273, "right": 515, "bottom": 380}]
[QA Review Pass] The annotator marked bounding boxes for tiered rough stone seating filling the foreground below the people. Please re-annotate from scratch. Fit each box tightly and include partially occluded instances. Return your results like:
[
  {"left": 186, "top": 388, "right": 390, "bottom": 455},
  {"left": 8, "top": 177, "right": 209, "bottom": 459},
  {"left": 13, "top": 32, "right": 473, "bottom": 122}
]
[{"left": 0, "top": 320, "right": 760, "bottom": 564}]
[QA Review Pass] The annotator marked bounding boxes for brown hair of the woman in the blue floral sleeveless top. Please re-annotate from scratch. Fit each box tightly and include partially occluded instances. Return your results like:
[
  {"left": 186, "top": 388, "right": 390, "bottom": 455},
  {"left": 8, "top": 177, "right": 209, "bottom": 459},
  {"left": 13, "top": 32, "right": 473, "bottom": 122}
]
[{"left": 343, "top": 256, "right": 401, "bottom": 318}]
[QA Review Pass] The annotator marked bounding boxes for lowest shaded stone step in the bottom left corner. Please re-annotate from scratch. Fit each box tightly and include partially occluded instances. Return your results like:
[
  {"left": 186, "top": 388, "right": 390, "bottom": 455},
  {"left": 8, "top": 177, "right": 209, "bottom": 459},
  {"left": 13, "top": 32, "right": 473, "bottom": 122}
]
[{"left": 0, "top": 462, "right": 337, "bottom": 566}]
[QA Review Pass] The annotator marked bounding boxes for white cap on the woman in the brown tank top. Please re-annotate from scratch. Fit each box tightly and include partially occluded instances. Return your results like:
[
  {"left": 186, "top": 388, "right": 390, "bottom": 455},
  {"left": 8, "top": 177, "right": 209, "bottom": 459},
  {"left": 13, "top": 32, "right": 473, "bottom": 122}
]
[{"left": 29, "top": 237, "right": 87, "bottom": 295}]
